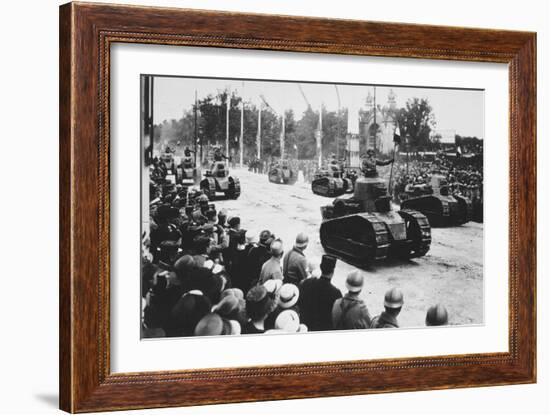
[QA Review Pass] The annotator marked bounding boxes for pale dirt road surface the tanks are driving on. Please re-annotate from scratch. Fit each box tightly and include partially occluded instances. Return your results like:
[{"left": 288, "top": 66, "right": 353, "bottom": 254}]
[{"left": 210, "top": 169, "right": 483, "bottom": 327}]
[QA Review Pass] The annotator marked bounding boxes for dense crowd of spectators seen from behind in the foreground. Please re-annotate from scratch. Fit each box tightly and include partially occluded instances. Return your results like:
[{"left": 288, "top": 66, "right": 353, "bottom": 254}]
[{"left": 141, "top": 162, "right": 448, "bottom": 337}]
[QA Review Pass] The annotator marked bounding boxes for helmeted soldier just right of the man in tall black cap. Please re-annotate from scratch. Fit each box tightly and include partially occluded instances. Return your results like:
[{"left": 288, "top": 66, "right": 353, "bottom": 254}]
[{"left": 332, "top": 271, "right": 371, "bottom": 330}]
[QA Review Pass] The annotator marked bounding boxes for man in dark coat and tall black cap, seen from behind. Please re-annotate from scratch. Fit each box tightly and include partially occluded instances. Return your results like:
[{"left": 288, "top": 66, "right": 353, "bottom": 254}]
[{"left": 298, "top": 255, "right": 342, "bottom": 331}]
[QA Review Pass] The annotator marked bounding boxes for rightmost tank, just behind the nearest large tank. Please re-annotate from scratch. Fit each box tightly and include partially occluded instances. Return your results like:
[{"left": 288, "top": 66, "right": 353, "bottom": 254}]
[{"left": 401, "top": 174, "right": 473, "bottom": 227}]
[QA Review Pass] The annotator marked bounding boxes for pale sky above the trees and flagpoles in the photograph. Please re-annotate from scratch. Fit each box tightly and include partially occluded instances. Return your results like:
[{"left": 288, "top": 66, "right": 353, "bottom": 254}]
[{"left": 154, "top": 77, "right": 485, "bottom": 138}]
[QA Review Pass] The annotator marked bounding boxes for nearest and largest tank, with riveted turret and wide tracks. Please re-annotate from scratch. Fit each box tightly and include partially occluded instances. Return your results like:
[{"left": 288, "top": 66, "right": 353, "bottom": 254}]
[{"left": 320, "top": 177, "right": 432, "bottom": 267}]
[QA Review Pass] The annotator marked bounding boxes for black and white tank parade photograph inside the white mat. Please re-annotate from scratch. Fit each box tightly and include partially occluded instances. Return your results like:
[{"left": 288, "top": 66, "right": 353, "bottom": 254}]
[{"left": 140, "top": 74, "right": 485, "bottom": 339}]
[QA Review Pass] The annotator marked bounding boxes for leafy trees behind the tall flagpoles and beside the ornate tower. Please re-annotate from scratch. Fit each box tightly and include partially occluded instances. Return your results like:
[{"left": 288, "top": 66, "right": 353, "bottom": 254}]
[{"left": 155, "top": 90, "right": 448, "bottom": 159}]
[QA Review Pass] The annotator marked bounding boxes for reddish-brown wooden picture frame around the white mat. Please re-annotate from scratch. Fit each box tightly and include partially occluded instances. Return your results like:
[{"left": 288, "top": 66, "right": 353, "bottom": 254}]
[{"left": 59, "top": 3, "right": 536, "bottom": 412}]
